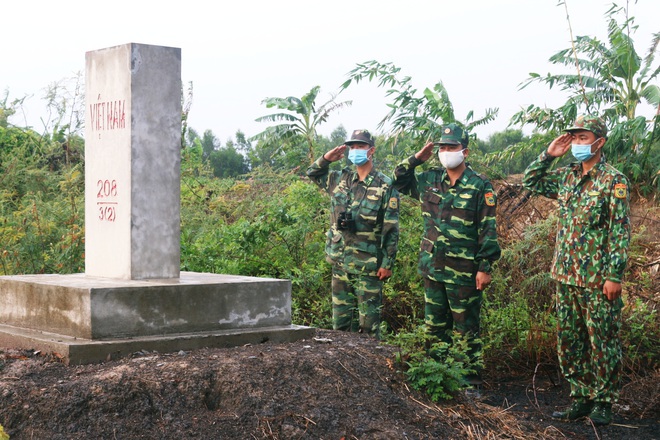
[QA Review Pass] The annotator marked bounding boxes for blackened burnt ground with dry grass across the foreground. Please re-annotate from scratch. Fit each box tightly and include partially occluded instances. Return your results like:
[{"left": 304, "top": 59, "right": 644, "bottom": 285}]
[{"left": 0, "top": 330, "right": 660, "bottom": 440}]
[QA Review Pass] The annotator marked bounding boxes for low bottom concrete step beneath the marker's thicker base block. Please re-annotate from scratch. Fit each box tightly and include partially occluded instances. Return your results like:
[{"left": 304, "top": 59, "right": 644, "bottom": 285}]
[{"left": 0, "top": 325, "right": 316, "bottom": 365}]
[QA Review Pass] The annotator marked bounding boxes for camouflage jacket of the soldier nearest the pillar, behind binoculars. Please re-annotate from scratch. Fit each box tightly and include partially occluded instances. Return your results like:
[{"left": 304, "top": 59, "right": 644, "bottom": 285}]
[{"left": 307, "top": 157, "right": 399, "bottom": 276}]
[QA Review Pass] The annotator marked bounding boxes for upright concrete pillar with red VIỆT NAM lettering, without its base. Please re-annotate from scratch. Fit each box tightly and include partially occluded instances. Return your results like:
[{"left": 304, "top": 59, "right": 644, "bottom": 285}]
[{"left": 85, "top": 43, "right": 181, "bottom": 280}]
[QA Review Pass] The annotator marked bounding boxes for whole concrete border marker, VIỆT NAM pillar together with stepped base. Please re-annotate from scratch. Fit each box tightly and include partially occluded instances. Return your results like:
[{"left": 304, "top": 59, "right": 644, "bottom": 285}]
[{"left": 0, "top": 43, "right": 314, "bottom": 364}]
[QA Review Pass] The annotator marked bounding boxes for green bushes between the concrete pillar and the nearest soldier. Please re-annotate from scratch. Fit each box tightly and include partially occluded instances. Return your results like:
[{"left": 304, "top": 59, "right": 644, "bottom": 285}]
[{"left": 181, "top": 150, "right": 331, "bottom": 327}]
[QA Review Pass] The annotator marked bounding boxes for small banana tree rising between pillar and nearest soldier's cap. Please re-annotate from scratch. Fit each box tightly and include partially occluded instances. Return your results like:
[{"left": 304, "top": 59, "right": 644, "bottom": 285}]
[{"left": 250, "top": 86, "right": 351, "bottom": 163}]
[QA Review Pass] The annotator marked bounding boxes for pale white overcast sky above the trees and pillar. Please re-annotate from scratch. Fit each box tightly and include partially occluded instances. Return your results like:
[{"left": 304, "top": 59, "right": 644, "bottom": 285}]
[{"left": 0, "top": 0, "right": 660, "bottom": 145}]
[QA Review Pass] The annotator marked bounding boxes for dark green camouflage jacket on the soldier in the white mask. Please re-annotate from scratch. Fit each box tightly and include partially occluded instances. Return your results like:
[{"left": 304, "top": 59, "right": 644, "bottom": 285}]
[{"left": 393, "top": 156, "right": 501, "bottom": 286}]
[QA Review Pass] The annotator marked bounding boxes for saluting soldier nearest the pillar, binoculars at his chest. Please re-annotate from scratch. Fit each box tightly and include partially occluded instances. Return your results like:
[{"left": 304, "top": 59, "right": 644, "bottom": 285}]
[{"left": 307, "top": 130, "right": 399, "bottom": 337}]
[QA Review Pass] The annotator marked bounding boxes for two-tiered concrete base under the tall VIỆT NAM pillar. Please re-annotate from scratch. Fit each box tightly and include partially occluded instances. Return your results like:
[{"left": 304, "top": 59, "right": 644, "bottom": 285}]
[{"left": 0, "top": 272, "right": 314, "bottom": 364}]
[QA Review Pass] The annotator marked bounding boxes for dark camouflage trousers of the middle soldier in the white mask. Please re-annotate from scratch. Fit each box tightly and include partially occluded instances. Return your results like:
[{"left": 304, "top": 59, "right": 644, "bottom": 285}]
[{"left": 424, "top": 278, "right": 483, "bottom": 363}]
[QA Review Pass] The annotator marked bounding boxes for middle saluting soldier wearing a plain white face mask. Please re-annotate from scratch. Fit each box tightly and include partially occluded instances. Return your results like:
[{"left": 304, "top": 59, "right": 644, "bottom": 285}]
[{"left": 394, "top": 124, "right": 501, "bottom": 396}]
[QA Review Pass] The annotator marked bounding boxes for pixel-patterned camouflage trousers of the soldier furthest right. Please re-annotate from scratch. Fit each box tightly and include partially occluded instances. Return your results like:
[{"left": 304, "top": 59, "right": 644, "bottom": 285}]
[{"left": 557, "top": 284, "right": 623, "bottom": 403}]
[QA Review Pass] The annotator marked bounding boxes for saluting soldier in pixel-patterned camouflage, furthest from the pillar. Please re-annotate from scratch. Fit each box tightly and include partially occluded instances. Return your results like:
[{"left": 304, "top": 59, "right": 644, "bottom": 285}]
[{"left": 523, "top": 116, "right": 630, "bottom": 425}]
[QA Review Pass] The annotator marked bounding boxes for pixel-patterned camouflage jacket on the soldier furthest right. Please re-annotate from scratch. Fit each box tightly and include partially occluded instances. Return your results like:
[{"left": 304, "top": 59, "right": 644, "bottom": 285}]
[{"left": 523, "top": 152, "right": 630, "bottom": 289}]
